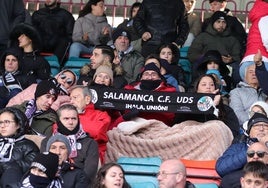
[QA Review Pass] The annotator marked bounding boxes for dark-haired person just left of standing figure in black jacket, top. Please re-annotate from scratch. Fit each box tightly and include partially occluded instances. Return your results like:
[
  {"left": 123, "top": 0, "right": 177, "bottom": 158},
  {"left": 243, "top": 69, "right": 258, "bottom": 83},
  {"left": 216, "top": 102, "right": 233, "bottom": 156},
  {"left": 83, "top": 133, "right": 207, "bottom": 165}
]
[{"left": 117, "top": 2, "right": 141, "bottom": 52}]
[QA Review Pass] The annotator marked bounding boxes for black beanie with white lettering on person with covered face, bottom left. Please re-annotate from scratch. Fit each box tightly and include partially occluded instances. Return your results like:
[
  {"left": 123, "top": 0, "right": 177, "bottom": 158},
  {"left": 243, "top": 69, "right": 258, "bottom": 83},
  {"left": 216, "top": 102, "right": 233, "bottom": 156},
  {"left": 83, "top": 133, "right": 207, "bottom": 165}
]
[{"left": 31, "top": 152, "right": 59, "bottom": 180}]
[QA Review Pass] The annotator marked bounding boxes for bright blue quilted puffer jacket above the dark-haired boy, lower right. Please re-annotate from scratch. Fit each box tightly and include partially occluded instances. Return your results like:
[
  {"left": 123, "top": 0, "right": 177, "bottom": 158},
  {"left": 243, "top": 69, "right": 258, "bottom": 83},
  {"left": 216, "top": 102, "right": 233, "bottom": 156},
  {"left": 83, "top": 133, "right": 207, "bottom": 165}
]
[{"left": 216, "top": 142, "right": 248, "bottom": 177}]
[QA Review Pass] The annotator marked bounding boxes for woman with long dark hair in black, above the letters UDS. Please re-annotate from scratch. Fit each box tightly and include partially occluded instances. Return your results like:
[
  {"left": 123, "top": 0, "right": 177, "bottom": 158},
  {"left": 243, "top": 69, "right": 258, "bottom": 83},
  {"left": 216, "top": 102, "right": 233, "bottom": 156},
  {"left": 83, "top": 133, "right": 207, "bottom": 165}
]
[{"left": 158, "top": 43, "right": 186, "bottom": 91}]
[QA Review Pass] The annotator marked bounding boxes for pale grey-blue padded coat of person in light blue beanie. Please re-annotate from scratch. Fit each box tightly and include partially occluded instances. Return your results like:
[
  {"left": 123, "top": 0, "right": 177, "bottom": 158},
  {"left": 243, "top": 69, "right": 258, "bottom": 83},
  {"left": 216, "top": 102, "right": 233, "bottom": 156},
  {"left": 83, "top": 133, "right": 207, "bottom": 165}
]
[{"left": 229, "top": 81, "right": 267, "bottom": 125}]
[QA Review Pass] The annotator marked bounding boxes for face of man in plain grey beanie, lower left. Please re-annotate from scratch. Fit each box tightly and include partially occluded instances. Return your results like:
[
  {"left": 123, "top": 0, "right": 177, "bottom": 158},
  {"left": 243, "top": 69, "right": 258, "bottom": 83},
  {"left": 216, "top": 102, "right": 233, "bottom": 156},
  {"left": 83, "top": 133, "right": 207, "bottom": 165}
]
[{"left": 49, "top": 141, "right": 68, "bottom": 165}]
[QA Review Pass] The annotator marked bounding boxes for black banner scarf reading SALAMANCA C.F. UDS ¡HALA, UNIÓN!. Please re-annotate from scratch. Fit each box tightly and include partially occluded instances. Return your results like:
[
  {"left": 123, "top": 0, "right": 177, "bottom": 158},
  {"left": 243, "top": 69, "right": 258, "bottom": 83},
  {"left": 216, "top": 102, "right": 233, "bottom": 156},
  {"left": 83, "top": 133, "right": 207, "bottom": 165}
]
[{"left": 90, "top": 86, "right": 215, "bottom": 114}]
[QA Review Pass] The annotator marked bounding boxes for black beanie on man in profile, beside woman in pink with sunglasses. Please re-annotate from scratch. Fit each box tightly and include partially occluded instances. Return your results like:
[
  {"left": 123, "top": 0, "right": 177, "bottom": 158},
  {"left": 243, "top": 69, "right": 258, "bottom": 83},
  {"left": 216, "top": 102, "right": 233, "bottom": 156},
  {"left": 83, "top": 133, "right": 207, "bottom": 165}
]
[{"left": 34, "top": 79, "right": 59, "bottom": 99}]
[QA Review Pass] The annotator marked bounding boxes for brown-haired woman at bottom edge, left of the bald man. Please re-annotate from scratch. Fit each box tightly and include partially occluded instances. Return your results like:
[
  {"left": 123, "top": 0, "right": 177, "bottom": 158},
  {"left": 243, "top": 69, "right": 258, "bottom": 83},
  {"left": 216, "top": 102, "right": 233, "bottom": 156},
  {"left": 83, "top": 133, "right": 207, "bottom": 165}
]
[{"left": 93, "top": 163, "right": 130, "bottom": 188}]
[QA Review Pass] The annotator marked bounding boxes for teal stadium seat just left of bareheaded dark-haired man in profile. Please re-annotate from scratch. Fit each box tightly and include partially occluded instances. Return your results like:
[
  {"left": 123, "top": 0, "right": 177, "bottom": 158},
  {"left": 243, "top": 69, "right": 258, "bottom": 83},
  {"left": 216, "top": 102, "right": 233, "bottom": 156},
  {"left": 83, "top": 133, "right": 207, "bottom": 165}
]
[{"left": 63, "top": 57, "right": 90, "bottom": 76}]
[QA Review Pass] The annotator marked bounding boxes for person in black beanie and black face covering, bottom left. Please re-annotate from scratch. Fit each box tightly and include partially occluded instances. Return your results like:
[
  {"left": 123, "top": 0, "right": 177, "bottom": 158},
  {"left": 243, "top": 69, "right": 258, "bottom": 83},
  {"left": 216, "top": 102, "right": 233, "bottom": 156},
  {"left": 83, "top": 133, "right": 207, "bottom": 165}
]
[{"left": 19, "top": 152, "right": 62, "bottom": 188}]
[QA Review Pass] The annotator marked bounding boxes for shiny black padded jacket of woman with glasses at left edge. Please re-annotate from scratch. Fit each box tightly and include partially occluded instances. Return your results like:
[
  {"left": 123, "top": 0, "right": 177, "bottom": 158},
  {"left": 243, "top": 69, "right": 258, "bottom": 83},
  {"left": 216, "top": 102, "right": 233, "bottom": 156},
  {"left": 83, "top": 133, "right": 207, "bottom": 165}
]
[{"left": 0, "top": 117, "right": 39, "bottom": 187}]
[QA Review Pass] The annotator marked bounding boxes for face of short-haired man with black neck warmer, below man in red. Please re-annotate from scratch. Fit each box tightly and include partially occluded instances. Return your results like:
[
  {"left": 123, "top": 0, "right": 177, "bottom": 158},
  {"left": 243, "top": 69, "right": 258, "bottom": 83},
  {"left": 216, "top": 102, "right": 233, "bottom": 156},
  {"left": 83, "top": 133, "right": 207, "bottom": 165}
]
[{"left": 59, "top": 109, "right": 78, "bottom": 131}]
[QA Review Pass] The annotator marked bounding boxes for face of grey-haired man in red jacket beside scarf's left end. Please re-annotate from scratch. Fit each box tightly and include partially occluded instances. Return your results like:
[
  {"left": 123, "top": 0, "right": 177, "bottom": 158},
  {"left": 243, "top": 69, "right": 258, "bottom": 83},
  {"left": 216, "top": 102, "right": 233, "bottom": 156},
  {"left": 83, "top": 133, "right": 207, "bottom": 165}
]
[{"left": 70, "top": 88, "right": 91, "bottom": 112}]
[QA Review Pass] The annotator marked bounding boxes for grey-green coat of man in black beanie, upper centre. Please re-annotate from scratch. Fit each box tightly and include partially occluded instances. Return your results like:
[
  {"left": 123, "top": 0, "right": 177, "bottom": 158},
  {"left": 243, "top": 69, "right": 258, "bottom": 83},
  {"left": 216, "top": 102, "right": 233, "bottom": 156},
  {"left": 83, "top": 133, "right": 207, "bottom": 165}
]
[{"left": 120, "top": 50, "right": 144, "bottom": 84}]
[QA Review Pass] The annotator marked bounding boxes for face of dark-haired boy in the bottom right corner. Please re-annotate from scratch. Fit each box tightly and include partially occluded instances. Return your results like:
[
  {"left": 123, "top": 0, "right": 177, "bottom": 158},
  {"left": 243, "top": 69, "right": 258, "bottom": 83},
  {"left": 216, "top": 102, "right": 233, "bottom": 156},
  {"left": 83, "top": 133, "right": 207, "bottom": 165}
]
[{"left": 240, "top": 173, "right": 268, "bottom": 188}]
